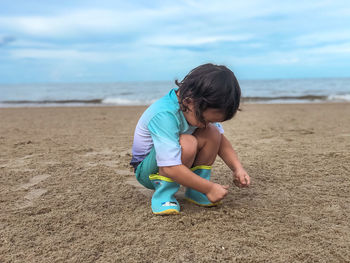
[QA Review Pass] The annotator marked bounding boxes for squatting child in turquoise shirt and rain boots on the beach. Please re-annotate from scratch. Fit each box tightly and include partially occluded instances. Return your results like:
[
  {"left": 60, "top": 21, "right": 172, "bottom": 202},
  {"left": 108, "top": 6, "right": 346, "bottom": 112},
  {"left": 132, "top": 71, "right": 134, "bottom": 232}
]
[{"left": 130, "top": 64, "right": 250, "bottom": 215}]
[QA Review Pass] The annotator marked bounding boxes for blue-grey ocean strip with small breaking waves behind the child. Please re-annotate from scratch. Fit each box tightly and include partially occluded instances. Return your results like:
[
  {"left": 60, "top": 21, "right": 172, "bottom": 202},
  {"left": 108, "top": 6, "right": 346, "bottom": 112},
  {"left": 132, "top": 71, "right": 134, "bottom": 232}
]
[{"left": 0, "top": 78, "right": 350, "bottom": 108}]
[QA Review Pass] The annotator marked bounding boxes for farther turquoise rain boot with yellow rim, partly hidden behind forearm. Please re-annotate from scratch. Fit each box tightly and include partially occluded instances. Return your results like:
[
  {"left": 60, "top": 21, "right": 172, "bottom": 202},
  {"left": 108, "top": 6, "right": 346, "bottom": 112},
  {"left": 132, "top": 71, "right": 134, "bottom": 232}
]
[{"left": 185, "top": 165, "right": 221, "bottom": 207}]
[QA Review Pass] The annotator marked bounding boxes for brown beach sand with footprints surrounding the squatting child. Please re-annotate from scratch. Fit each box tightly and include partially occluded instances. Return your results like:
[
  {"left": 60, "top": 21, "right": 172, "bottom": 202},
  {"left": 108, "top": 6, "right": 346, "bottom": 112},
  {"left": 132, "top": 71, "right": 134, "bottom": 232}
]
[{"left": 0, "top": 103, "right": 350, "bottom": 262}]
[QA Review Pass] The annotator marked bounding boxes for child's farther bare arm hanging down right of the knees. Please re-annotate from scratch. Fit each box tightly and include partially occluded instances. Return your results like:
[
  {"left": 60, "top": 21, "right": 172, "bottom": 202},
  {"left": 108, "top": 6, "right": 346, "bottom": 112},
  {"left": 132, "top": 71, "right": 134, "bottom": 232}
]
[{"left": 219, "top": 134, "right": 250, "bottom": 187}]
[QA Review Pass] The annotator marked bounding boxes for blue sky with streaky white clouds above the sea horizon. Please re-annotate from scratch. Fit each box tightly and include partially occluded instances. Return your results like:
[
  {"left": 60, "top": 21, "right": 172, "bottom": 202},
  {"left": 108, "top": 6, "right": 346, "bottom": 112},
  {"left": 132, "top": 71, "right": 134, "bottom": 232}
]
[{"left": 0, "top": 0, "right": 350, "bottom": 84}]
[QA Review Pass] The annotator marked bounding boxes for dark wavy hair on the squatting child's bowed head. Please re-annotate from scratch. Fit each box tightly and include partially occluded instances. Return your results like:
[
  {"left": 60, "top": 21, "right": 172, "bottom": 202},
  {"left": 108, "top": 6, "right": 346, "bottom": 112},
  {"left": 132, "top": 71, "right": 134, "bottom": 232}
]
[{"left": 175, "top": 64, "right": 241, "bottom": 122}]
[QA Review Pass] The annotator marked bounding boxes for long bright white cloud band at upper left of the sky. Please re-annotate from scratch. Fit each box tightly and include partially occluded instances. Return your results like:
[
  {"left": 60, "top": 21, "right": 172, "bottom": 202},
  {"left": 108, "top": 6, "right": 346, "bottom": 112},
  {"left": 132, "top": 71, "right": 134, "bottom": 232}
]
[{"left": 0, "top": 9, "right": 180, "bottom": 38}]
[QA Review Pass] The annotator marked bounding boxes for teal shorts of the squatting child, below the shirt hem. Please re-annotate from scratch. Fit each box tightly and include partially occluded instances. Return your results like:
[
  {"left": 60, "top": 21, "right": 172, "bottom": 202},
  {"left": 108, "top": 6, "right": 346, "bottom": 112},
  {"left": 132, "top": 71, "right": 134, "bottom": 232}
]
[{"left": 135, "top": 147, "right": 159, "bottom": 189}]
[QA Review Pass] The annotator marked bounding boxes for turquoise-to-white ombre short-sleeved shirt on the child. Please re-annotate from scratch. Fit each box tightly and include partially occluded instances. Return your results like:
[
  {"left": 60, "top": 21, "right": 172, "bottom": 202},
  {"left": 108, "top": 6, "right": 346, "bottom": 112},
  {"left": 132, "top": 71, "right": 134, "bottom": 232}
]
[{"left": 131, "top": 89, "right": 223, "bottom": 167}]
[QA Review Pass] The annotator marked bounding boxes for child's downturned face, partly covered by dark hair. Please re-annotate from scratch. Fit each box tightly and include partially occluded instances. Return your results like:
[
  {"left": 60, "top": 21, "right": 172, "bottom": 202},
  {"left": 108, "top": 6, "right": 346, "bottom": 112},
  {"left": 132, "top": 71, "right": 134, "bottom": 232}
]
[{"left": 183, "top": 102, "right": 225, "bottom": 128}]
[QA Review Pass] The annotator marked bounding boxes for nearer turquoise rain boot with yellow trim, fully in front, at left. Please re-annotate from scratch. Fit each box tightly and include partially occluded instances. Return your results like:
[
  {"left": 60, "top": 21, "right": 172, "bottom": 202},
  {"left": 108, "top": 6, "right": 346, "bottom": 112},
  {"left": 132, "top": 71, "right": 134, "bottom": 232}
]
[{"left": 149, "top": 174, "right": 180, "bottom": 215}]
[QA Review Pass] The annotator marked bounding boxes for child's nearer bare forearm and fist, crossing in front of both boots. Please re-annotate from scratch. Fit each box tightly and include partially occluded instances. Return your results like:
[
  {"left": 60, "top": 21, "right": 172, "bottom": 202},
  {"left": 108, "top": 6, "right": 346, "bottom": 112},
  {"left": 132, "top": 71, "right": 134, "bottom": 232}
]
[{"left": 159, "top": 164, "right": 228, "bottom": 203}]
